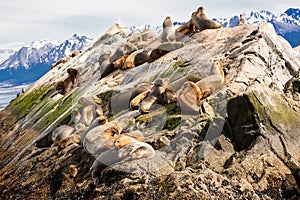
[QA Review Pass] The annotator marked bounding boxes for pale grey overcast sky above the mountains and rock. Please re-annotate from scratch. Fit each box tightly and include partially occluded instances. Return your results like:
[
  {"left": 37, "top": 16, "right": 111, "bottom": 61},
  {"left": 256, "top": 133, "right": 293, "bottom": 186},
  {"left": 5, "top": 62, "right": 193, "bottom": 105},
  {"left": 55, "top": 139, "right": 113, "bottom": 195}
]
[{"left": 0, "top": 0, "right": 300, "bottom": 50}]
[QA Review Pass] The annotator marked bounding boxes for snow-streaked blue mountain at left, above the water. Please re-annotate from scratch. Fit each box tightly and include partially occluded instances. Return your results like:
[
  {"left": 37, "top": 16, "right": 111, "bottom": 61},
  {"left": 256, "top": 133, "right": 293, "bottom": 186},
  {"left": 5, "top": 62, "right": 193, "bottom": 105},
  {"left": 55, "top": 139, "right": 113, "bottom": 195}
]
[{"left": 0, "top": 34, "right": 92, "bottom": 85}]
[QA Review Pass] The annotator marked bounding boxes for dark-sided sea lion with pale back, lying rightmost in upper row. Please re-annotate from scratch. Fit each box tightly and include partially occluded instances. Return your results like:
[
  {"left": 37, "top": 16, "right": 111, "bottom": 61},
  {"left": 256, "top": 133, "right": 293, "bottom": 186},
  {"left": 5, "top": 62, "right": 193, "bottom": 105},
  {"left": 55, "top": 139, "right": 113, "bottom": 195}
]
[{"left": 149, "top": 42, "right": 184, "bottom": 62}]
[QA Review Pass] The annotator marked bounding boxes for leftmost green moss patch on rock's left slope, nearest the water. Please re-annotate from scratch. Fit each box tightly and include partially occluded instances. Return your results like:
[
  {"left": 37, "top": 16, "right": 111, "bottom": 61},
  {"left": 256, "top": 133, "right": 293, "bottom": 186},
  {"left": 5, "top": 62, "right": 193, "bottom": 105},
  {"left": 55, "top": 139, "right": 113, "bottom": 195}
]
[{"left": 9, "top": 86, "right": 53, "bottom": 119}]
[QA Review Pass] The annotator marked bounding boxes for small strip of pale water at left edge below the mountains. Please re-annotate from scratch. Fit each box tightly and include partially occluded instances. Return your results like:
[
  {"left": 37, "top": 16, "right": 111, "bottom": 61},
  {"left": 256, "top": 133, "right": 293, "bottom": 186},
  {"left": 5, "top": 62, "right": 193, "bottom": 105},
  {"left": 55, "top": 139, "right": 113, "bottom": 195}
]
[{"left": 0, "top": 84, "right": 30, "bottom": 110}]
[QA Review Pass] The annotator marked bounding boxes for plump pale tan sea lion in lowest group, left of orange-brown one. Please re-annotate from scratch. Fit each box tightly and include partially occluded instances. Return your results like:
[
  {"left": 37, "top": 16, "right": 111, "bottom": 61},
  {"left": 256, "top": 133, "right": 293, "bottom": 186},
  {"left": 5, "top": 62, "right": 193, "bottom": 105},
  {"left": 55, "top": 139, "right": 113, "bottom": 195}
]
[{"left": 82, "top": 116, "right": 135, "bottom": 156}]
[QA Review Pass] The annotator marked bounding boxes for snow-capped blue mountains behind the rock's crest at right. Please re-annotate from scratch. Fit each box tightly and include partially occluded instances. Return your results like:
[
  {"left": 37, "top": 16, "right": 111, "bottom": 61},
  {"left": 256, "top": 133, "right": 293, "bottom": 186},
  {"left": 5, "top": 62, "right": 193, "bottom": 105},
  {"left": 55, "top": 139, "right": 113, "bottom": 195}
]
[{"left": 215, "top": 8, "right": 300, "bottom": 47}]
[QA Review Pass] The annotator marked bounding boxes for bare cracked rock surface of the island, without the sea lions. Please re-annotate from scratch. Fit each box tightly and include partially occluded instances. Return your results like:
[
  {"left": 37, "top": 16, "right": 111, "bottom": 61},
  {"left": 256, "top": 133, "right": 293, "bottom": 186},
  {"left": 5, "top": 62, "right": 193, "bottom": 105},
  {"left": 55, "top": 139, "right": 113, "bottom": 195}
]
[{"left": 0, "top": 24, "right": 300, "bottom": 199}]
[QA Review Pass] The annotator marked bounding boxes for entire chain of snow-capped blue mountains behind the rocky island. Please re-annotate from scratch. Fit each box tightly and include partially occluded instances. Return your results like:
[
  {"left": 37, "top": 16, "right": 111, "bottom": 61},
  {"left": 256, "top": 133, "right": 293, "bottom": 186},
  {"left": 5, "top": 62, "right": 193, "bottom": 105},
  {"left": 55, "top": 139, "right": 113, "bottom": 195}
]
[{"left": 0, "top": 8, "right": 300, "bottom": 85}]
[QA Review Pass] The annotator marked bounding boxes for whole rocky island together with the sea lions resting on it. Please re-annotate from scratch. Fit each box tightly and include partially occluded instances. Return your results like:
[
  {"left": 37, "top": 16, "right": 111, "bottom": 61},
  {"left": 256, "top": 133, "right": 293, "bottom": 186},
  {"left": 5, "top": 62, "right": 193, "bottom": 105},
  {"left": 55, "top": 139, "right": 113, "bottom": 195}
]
[{"left": 0, "top": 7, "right": 300, "bottom": 199}]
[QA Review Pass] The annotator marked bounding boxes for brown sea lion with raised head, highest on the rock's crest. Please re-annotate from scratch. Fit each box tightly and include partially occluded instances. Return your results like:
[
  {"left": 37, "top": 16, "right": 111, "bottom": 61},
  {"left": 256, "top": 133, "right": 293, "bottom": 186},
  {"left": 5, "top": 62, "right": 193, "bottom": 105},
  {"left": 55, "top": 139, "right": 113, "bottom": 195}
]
[{"left": 192, "top": 7, "right": 222, "bottom": 31}]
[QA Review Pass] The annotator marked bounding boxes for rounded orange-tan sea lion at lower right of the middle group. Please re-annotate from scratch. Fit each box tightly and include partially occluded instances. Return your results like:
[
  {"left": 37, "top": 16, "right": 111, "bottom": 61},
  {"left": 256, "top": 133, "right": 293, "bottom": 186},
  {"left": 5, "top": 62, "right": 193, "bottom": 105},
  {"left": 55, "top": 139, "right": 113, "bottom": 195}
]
[{"left": 177, "top": 81, "right": 202, "bottom": 114}]
